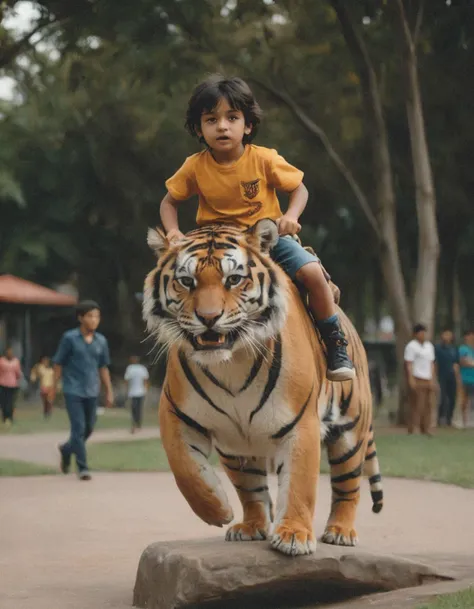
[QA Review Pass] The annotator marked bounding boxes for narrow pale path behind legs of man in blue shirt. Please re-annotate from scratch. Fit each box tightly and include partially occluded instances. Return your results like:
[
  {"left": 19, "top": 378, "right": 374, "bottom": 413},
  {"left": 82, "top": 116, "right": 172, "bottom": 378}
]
[{"left": 0, "top": 427, "right": 160, "bottom": 467}]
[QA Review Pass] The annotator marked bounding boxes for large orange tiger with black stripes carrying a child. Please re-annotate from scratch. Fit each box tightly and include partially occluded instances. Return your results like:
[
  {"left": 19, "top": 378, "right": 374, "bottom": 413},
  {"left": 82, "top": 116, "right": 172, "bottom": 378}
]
[{"left": 143, "top": 219, "right": 383, "bottom": 556}]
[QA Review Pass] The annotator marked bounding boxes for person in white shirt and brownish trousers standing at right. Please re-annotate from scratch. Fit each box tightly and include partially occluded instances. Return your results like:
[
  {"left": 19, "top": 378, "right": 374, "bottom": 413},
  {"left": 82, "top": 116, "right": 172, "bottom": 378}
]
[{"left": 404, "top": 324, "right": 438, "bottom": 436}]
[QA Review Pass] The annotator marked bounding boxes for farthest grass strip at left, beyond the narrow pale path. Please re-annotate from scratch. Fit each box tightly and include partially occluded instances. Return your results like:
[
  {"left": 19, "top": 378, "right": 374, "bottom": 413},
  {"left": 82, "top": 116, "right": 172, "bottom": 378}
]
[{"left": 0, "top": 403, "right": 158, "bottom": 437}]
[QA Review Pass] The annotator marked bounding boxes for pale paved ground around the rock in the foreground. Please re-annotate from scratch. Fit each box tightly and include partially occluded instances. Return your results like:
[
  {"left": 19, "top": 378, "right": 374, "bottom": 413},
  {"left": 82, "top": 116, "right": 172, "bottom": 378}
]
[{"left": 0, "top": 472, "right": 474, "bottom": 609}]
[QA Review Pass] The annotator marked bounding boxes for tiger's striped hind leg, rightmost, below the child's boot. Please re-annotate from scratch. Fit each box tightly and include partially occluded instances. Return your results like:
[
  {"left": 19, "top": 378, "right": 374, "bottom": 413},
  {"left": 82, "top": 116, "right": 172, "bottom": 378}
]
[{"left": 322, "top": 432, "right": 368, "bottom": 546}]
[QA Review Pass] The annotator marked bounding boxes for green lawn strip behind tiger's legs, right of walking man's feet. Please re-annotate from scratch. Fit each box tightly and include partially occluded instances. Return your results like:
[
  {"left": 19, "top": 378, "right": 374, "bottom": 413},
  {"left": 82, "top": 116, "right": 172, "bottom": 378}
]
[{"left": 88, "top": 430, "right": 474, "bottom": 488}]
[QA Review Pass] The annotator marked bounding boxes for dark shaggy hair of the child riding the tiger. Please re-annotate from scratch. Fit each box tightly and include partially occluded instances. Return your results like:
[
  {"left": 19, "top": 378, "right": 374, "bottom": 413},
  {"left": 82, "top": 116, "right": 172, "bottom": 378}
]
[{"left": 184, "top": 74, "right": 262, "bottom": 144}]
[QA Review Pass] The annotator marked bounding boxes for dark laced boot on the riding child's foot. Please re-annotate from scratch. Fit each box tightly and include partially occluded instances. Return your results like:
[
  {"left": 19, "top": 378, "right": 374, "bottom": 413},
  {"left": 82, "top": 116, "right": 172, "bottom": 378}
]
[{"left": 317, "top": 315, "right": 355, "bottom": 381}]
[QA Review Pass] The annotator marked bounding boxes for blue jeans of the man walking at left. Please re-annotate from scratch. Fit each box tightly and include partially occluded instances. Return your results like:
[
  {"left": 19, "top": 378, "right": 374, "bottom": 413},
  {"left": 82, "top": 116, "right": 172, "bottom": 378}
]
[{"left": 61, "top": 393, "right": 97, "bottom": 472}]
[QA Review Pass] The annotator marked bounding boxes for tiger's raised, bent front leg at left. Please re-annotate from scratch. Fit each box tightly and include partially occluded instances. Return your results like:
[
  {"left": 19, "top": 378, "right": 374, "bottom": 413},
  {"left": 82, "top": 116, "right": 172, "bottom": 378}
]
[{"left": 160, "top": 389, "right": 233, "bottom": 527}]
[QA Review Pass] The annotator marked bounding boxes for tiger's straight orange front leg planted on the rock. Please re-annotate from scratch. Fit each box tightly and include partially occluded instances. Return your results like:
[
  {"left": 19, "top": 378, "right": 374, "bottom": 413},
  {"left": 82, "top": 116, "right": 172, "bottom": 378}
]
[{"left": 271, "top": 408, "right": 321, "bottom": 556}]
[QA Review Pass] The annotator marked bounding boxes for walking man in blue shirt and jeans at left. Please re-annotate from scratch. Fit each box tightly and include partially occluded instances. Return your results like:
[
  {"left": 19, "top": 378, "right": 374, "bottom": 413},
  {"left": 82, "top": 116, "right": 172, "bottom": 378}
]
[{"left": 51, "top": 300, "right": 114, "bottom": 480}]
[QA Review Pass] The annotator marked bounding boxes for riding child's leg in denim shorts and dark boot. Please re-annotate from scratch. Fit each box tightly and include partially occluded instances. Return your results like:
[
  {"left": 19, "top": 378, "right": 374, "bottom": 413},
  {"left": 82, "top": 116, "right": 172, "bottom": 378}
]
[{"left": 271, "top": 237, "right": 355, "bottom": 381}]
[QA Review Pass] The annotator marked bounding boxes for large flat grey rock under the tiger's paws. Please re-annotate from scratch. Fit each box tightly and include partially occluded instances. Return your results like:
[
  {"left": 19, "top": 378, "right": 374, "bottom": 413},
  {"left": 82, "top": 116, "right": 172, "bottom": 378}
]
[{"left": 133, "top": 539, "right": 451, "bottom": 609}]
